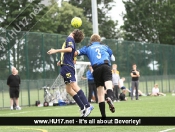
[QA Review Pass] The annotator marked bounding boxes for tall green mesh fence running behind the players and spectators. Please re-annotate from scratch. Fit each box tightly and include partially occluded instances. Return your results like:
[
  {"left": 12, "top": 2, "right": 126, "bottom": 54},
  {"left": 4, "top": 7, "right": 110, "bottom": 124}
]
[{"left": 0, "top": 31, "right": 175, "bottom": 107}]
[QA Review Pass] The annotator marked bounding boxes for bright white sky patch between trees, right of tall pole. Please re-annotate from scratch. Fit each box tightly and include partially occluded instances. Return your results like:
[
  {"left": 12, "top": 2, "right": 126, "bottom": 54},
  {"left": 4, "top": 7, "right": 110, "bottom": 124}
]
[{"left": 109, "top": 0, "right": 125, "bottom": 27}]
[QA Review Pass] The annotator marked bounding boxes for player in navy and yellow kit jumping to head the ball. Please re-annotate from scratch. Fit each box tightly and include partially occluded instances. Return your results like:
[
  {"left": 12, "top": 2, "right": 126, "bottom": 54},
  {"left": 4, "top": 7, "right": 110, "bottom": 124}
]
[{"left": 47, "top": 29, "right": 93, "bottom": 117}]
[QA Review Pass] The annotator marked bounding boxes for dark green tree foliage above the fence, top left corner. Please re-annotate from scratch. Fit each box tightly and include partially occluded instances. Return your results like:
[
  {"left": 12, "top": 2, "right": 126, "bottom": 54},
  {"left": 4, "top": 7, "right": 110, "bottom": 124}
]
[{"left": 0, "top": 0, "right": 48, "bottom": 32}]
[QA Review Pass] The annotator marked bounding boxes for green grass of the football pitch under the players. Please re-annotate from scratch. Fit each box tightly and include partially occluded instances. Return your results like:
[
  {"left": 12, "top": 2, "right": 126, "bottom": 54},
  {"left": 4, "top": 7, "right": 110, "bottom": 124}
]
[{"left": 0, "top": 94, "right": 175, "bottom": 132}]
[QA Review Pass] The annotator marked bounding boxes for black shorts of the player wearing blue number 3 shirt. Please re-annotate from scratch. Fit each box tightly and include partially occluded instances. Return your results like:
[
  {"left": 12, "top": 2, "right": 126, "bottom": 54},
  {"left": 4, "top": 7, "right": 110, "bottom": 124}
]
[{"left": 93, "top": 64, "right": 112, "bottom": 87}]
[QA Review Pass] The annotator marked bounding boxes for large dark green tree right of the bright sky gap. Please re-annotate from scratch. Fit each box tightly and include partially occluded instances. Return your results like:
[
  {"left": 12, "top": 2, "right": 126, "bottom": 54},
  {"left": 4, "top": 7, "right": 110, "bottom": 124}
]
[{"left": 122, "top": 0, "right": 175, "bottom": 75}]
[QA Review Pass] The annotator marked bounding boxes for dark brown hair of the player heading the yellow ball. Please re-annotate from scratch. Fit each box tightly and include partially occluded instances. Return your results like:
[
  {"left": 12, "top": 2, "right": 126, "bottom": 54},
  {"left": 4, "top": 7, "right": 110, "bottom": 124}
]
[{"left": 72, "top": 29, "right": 84, "bottom": 43}]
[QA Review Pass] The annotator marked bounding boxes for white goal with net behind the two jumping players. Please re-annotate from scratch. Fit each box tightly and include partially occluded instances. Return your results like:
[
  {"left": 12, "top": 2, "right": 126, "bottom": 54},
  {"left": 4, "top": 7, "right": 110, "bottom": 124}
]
[{"left": 48, "top": 61, "right": 90, "bottom": 104}]
